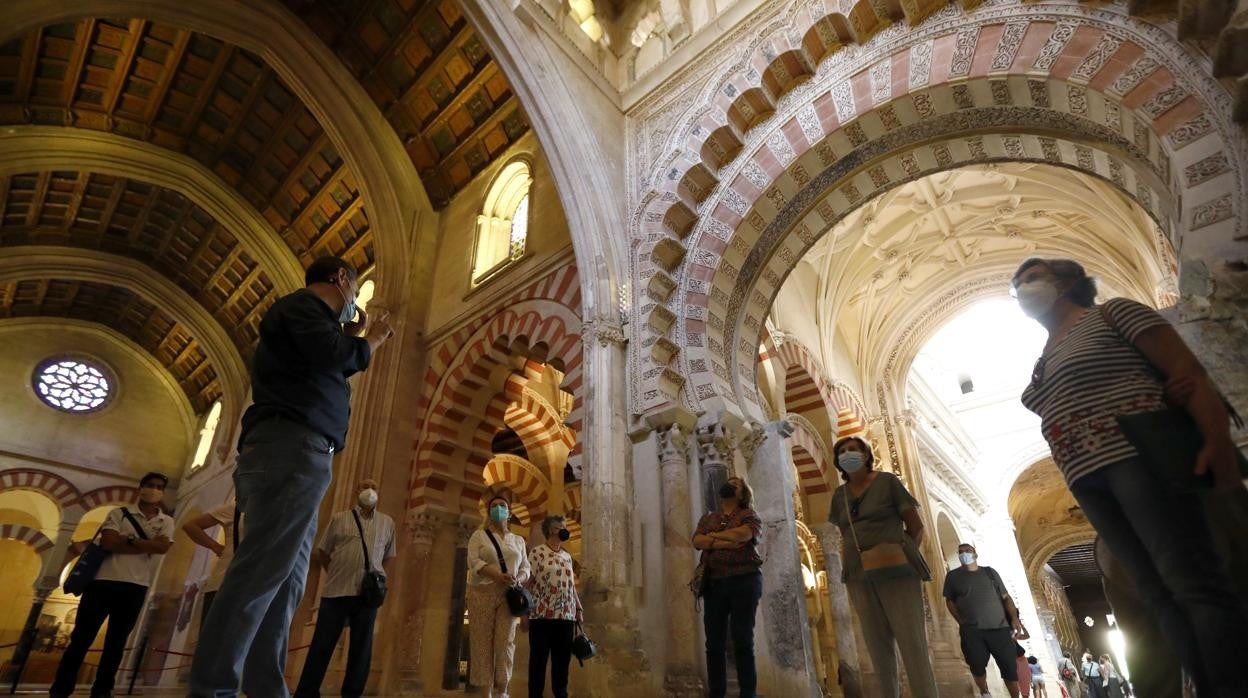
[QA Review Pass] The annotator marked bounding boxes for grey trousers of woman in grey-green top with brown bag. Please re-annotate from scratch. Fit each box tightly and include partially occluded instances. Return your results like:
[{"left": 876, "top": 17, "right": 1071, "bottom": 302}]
[{"left": 845, "top": 577, "right": 937, "bottom": 698}]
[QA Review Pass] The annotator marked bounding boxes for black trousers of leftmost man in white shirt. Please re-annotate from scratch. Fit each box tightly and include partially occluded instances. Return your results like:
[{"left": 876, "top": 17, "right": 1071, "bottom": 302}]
[{"left": 49, "top": 579, "right": 147, "bottom": 696}]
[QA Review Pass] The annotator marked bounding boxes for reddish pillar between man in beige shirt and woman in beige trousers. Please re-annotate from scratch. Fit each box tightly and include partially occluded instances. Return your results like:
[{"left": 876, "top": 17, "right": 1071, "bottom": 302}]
[{"left": 373, "top": 511, "right": 447, "bottom": 696}]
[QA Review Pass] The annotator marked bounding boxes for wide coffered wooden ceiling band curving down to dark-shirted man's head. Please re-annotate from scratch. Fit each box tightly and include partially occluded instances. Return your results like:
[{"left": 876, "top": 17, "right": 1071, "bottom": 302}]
[{"left": 0, "top": 19, "right": 373, "bottom": 268}]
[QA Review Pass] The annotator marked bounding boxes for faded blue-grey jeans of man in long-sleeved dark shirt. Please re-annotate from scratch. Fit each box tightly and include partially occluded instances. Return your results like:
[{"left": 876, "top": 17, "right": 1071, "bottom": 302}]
[{"left": 190, "top": 418, "right": 333, "bottom": 698}]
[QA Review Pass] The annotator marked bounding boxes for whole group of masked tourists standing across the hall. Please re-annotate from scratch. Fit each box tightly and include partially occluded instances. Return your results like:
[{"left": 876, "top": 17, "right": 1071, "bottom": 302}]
[{"left": 43, "top": 257, "right": 1248, "bottom": 698}]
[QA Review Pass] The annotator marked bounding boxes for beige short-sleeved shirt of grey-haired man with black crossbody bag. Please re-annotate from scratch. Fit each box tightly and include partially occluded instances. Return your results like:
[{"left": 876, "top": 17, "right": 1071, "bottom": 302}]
[{"left": 317, "top": 507, "right": 394, "bottom": 598}]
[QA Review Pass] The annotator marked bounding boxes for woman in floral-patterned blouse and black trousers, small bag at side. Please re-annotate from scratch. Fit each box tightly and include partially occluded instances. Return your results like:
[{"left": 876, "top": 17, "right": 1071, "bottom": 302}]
[{"left": 520, "top": 516, "right": 583, "bottom": 698}]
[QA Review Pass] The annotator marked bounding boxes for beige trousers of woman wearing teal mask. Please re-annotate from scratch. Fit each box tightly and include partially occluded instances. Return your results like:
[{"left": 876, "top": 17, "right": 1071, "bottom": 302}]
[{"left": 466, "top": 582, "right": 518, "bottom": 698}]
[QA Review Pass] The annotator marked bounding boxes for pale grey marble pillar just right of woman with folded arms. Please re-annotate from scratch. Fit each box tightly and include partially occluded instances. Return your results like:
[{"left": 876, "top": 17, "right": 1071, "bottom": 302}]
[{"left": 740, "top": 421, "right": 821, "bottom": 696}]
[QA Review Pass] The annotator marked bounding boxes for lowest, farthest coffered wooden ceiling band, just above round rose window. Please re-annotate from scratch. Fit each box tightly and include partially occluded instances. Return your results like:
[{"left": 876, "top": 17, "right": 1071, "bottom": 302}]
[{"left": 0, "top": 278, "right": 221, "bottom": 413}]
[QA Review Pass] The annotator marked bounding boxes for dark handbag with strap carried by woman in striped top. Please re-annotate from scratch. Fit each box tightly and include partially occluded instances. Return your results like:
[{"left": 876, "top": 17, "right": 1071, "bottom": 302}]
[{"left": 1097, "top": 306, "right": 1248, "bottom": 492}]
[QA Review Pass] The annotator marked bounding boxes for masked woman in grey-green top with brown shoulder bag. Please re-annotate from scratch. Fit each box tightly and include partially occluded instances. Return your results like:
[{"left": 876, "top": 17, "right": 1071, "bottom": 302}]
[{"left": 827, "top": 436, "right": 936, "bottom": 698}]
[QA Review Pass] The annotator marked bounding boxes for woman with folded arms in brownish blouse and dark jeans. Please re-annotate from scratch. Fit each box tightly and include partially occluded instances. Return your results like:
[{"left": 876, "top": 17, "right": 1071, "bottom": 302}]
[{"left": 694, "top": 477, "right": 763, "bottom": 698}]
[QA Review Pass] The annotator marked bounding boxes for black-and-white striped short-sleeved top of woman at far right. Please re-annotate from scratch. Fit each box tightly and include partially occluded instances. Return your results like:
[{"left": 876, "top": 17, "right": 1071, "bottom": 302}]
[{"left": 1022, "top": 298, "right": 1166, "bottom": 484}]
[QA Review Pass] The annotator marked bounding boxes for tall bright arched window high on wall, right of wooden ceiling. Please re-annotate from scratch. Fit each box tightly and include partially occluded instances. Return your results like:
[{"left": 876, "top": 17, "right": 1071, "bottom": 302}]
[{"left": 472, "top": 160, "right": 533, "bottom": 286}]
